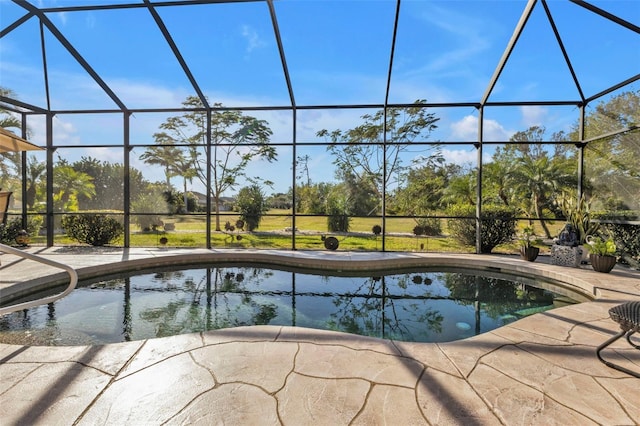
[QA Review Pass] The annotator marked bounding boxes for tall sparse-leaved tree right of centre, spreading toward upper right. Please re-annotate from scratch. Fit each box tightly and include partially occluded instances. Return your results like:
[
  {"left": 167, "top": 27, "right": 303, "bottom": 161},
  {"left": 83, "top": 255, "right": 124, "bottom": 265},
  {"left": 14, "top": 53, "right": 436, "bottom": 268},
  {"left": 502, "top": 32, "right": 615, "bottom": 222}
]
[{"left": 317, "top": 99, "right": 439, "bottom": 213}]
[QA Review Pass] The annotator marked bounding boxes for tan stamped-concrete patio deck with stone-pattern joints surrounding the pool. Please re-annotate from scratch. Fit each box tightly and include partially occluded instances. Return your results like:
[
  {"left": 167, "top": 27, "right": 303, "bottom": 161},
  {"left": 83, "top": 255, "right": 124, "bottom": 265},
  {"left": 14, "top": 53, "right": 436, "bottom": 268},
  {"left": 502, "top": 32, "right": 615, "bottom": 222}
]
[{"left": 0, "top": 247, "right": 640, "bottom": 426}]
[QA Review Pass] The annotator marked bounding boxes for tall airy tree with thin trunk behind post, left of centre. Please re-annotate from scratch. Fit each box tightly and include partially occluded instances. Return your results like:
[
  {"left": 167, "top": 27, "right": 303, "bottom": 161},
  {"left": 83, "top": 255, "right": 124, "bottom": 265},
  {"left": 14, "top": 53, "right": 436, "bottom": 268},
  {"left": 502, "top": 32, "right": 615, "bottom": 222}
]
[{"left": 154, "top": 96, "right": 277, "bottom": 231}]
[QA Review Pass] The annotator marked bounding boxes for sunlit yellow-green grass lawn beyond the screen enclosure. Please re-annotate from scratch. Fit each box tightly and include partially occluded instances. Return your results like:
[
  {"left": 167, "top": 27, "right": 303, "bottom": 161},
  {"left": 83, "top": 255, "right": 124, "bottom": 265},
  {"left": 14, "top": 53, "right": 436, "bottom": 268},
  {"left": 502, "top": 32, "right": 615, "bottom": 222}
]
[{"left": 31, "top": 210, "right": 563, "bottom": 254}]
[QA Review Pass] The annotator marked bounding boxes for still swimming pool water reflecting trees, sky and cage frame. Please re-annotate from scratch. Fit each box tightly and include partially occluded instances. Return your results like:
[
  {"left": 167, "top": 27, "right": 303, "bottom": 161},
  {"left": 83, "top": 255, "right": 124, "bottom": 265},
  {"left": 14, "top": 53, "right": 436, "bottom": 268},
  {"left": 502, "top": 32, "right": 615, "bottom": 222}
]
[{"left": 0, "top": 265, "right": 575, "bottom": 345}]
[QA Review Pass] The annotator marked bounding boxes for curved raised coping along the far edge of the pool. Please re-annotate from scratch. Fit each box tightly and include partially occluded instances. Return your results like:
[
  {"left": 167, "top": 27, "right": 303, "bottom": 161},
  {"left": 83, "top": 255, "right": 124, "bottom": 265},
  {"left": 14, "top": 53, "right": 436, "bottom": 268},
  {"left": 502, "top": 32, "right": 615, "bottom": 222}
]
[{"left": 0, "top": 250, "right": 600, "bottom": 304}]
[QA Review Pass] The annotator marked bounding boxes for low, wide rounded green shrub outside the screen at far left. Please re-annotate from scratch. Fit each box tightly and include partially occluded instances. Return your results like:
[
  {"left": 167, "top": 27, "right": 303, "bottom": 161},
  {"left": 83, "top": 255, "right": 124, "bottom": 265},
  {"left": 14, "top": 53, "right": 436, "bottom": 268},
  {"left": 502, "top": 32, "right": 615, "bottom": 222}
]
[{"left": 62, "top": 214, "right": 124, "bottom": 246}]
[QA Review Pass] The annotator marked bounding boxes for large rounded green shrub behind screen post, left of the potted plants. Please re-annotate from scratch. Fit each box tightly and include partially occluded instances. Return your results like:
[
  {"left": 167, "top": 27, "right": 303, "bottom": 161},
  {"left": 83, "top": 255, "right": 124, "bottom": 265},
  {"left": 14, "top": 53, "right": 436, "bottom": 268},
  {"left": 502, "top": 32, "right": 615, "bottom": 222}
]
[{"left": 449, "top": 206, "right": 517, "bottom": 253}]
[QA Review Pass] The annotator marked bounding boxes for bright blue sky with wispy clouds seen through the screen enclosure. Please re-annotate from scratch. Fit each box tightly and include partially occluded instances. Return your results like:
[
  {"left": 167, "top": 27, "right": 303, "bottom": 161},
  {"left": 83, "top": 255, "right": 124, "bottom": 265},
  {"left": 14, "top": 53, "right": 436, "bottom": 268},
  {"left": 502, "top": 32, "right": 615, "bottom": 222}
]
[{"left": 0, "top": 0, "right": 640, "bottom": 190}]
